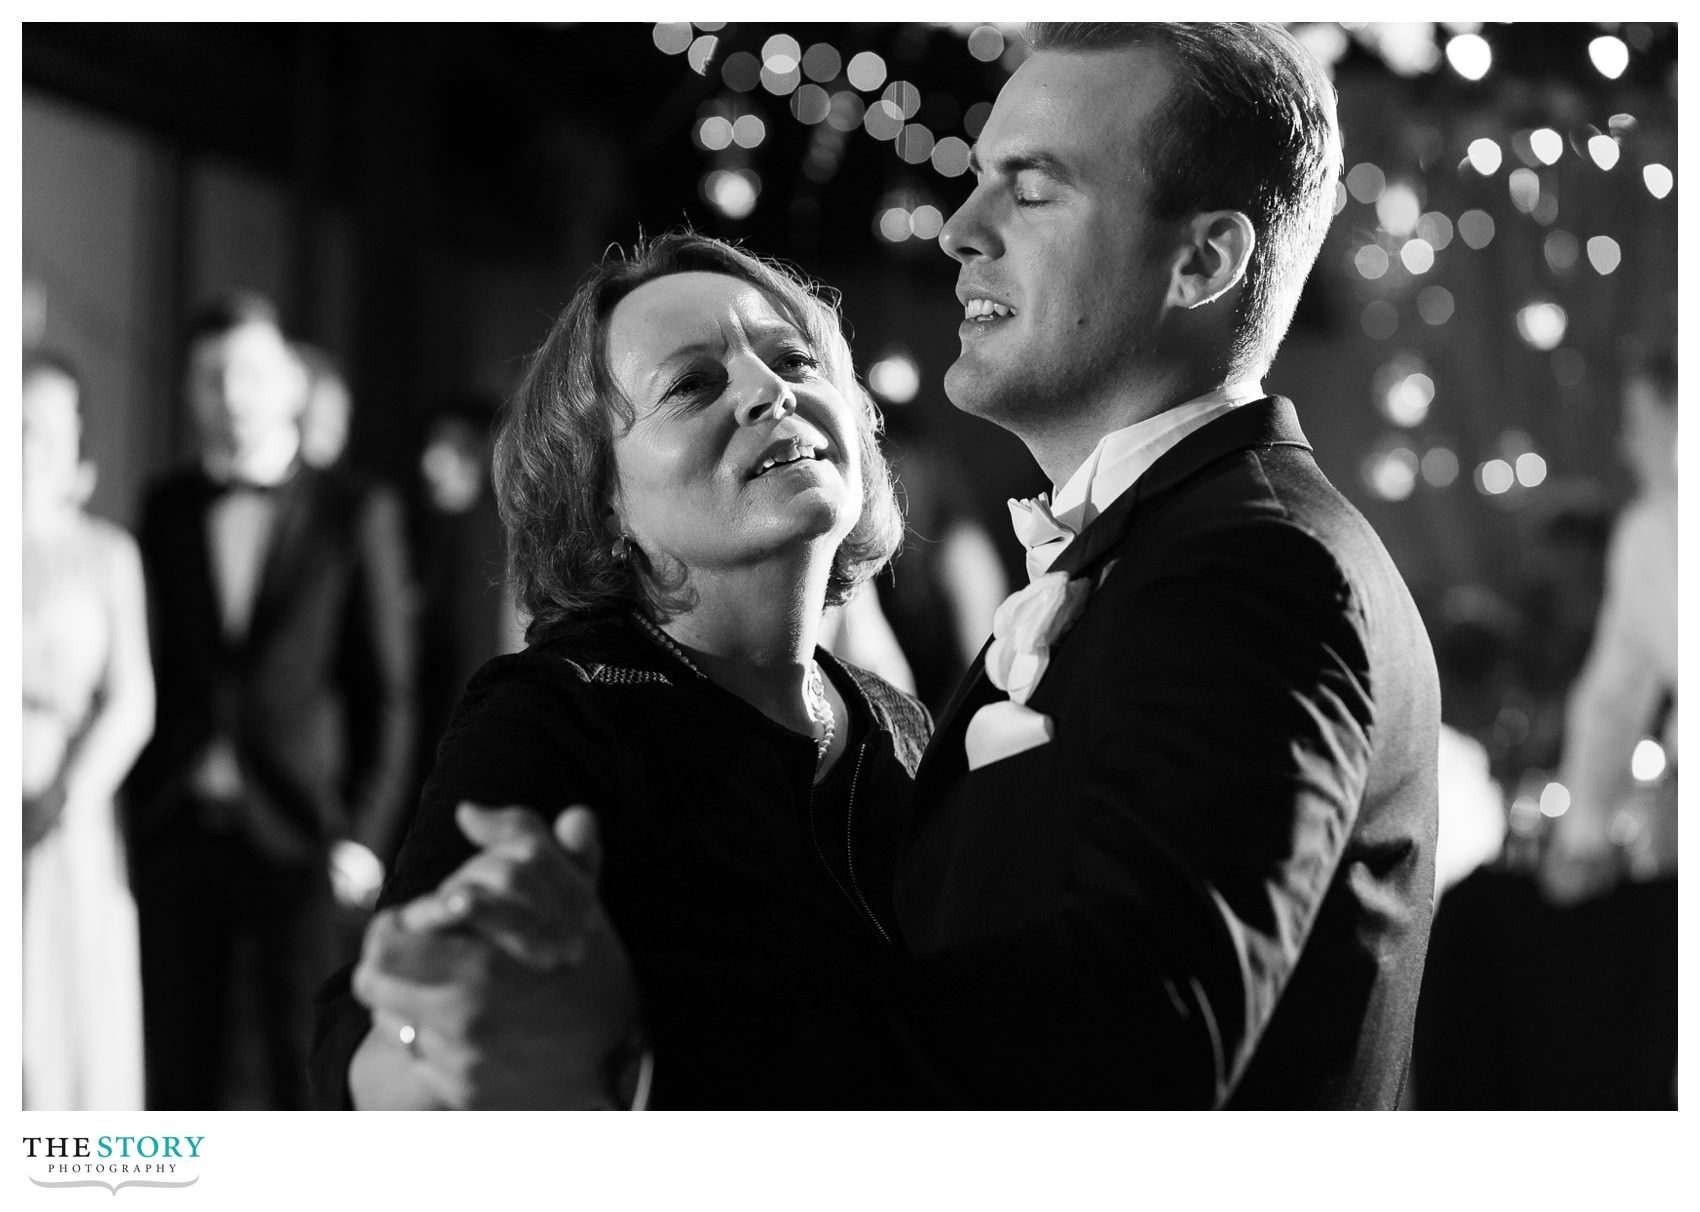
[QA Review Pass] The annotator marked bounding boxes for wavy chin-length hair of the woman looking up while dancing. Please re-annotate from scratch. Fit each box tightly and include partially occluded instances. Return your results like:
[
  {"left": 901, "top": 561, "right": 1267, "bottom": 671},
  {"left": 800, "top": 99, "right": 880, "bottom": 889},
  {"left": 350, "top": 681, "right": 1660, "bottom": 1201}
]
[{"left": 495, "top": 231, "right": 903, "bottom": 637}]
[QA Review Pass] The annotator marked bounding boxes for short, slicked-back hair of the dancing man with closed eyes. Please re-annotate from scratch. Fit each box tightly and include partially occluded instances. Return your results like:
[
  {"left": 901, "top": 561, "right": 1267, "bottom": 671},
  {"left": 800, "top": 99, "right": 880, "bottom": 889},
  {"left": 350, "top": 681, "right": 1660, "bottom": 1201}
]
[{"left": 1027, "top": 22, "right": 1341, "bottom": 372}]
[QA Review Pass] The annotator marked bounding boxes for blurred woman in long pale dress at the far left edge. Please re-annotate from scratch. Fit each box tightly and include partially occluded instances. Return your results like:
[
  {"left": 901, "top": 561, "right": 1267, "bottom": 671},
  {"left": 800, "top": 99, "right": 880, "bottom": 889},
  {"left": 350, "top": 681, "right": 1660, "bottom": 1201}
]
[{"left": 20, "top": 352, "right": 153, "bottom": 1110}]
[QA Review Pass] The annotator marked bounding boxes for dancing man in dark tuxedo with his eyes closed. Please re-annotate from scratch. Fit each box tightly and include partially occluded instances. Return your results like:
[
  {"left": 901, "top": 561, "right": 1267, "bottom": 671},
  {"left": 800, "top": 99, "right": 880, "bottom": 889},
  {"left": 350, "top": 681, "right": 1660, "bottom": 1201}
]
[{"left": 334, "top": 25, "right": 1440, "bottom": 1108}]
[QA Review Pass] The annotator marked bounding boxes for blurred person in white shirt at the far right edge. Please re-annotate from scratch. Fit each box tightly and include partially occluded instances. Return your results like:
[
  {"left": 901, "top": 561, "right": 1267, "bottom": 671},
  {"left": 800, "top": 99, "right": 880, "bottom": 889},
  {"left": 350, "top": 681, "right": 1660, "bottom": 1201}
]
[{"left": 1542, "top": 339, "right": 1676, "bottom": 903}]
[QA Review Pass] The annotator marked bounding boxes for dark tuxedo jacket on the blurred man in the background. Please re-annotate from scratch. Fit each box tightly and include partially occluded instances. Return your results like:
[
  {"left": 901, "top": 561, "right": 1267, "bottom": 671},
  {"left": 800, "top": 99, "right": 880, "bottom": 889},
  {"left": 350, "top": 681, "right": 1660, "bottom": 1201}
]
[{"left": 129, "top": 467, "right": 417, "bottom": 865}]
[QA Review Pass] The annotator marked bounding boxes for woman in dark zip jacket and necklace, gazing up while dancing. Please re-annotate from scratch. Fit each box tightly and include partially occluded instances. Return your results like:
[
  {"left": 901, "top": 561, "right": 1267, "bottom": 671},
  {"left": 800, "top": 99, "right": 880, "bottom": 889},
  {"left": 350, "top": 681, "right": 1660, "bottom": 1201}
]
[{"left": 315, "top": 235, "right": 927, "bottom": 1107}]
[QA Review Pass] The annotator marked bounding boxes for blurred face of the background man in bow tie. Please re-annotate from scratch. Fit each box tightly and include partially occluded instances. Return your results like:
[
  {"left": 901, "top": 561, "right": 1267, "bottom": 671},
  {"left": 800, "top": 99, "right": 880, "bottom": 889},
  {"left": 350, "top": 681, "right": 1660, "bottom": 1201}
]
[{"left": 189, "top": 323, "right": 306, "bottom": 459}]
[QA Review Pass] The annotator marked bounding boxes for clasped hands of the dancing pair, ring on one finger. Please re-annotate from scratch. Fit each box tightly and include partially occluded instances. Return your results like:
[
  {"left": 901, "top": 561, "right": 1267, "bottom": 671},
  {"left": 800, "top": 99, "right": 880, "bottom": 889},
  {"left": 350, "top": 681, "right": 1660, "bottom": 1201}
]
[{"left": 349, "top": 804, "right": 639, "bottom": 1108}]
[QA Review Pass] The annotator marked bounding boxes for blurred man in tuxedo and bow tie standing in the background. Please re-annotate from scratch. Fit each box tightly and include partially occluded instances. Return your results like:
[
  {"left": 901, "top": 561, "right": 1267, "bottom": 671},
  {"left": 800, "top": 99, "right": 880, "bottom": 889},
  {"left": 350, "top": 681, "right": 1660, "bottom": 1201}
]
[{"left": 129, "top": 296, "right": 415, "bottom": 1108}]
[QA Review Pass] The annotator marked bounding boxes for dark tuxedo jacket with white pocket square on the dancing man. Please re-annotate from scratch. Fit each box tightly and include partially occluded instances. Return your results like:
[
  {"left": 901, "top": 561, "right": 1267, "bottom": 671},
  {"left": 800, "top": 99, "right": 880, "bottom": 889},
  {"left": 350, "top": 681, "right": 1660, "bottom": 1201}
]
[{"left": 802, "top": 398, "right": 1440, "bottom": 1108}]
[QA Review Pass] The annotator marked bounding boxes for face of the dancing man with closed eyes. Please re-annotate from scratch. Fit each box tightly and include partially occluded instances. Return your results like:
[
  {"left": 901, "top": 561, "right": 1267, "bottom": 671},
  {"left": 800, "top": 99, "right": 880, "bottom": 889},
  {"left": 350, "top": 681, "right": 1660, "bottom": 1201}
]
[{"left": 940, "top": 48, "right": 1183, "bottom": 433}]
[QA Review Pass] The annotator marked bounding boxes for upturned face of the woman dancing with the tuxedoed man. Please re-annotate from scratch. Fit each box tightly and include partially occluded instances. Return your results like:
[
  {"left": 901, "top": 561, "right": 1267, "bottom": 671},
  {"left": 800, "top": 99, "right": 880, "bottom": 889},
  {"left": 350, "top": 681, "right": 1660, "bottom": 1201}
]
[{"left": 609, "top": 274, "right": 862, "bottom": 573}]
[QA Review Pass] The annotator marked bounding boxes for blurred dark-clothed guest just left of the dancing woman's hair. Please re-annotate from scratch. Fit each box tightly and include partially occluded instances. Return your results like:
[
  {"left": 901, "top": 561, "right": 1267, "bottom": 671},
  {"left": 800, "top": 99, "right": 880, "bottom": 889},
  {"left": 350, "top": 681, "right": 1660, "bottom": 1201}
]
[{"left": 415, "top": 393, "right": 525, "bottom": 782}]
